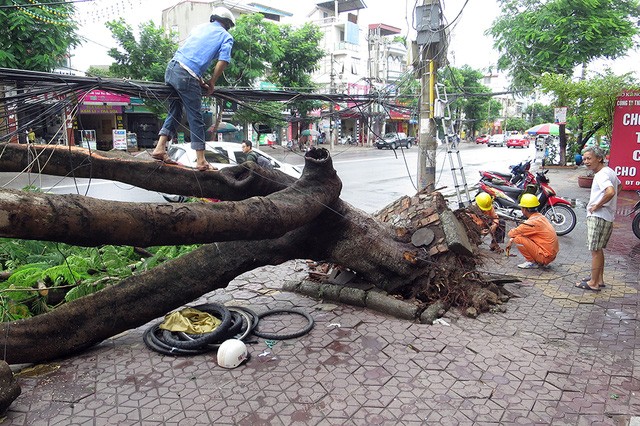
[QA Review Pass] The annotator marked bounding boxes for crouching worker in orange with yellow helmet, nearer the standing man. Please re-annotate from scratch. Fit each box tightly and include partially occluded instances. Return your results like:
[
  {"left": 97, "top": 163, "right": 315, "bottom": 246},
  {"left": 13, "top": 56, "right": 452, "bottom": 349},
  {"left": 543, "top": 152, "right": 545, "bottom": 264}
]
[{"left": 506, "top": 194, "right": 560, "bottom": 269}]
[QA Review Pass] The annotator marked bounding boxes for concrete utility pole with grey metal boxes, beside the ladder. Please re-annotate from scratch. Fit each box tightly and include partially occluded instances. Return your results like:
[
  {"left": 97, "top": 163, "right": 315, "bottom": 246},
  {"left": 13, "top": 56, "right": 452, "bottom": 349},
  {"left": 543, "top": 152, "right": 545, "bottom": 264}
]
[{"left": 416, "top": 0, "right": 446, "bottom": 191}]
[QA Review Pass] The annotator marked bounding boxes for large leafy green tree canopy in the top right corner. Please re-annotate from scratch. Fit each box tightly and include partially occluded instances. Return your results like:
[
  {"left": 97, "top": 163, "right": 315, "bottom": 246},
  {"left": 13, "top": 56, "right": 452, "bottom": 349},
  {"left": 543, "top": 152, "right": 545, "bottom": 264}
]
[{"left": 487, "top": 0, "right": 640, "bottom": 88}]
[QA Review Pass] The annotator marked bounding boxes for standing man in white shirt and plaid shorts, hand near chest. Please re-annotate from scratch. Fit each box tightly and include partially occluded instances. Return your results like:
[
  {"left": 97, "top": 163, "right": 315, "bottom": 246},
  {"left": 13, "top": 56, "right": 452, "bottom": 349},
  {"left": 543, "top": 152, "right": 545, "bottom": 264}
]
[{"left": 576, "top": 147, "right": 622, "bottom": 291}]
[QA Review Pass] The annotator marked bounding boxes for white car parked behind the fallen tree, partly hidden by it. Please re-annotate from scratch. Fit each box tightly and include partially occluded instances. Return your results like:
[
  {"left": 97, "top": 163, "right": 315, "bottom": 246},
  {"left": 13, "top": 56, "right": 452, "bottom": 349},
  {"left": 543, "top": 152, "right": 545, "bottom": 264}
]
[{"left": 162, "top": 142, "right": 302, "bottom": 203}]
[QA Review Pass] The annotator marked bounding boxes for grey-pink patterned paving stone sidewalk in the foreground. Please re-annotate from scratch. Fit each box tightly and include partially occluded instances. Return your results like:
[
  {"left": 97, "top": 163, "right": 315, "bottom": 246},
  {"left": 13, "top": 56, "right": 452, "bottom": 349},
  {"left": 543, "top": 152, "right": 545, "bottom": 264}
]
[{"left": 2, "top": 166, "right": 640, "bottom": 425}]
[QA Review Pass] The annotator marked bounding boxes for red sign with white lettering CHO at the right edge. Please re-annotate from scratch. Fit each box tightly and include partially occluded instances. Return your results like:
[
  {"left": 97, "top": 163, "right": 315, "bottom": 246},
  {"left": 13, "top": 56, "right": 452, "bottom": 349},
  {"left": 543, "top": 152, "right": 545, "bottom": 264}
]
[{"left": 609, "top": 92, "right": 640, "bottom": 190}]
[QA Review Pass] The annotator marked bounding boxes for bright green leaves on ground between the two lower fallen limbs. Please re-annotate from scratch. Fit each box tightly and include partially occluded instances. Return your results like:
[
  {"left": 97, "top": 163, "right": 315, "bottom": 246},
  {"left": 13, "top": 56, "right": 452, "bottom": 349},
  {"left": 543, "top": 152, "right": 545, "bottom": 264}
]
[{"left": 0, "top": 239, "right": 197, "bottom": 322}]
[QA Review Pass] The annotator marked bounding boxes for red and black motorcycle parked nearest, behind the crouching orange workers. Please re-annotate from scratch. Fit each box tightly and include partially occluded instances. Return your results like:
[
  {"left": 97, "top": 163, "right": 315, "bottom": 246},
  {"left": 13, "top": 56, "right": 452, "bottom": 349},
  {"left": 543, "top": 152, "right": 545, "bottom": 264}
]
[{"left": 478, "top": 171, "right": 576, "bottom": 238}]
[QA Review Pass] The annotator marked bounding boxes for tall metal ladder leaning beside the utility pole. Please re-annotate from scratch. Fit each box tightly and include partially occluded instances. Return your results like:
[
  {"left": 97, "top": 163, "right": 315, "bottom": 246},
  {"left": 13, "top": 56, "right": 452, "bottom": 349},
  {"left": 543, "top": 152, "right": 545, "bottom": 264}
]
[{"left": 434, "top": 83, "right": 471, "bottom": 208}]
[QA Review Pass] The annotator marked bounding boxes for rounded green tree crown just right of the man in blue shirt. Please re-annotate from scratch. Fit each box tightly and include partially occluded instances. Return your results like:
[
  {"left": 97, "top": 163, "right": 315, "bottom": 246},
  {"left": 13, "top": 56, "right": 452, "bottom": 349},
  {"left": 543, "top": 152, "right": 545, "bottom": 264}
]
[{"left": 224, "top": 13, "right": 283, "bottom": 87}]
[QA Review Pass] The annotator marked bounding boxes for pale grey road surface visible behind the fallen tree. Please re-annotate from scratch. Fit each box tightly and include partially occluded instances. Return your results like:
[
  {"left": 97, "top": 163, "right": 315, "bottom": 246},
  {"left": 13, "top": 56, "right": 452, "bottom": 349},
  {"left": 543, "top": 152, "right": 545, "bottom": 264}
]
[{"left": 0, "top": 143, "right": 535, "bottom": 213}]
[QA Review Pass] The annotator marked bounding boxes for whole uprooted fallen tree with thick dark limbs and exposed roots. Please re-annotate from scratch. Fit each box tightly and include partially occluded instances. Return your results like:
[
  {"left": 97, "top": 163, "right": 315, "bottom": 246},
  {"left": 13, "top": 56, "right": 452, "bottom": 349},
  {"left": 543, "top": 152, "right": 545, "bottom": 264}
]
[{"left": 0, "top": 144, "right": 500, "bottom": 363}]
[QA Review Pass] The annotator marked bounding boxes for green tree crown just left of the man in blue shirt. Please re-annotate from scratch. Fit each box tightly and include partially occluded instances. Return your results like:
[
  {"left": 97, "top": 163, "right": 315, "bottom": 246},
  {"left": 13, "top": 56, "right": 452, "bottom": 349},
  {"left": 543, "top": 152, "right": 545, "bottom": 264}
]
[{"left": 105, "top": 19, "right": 178, "bottom": 82}]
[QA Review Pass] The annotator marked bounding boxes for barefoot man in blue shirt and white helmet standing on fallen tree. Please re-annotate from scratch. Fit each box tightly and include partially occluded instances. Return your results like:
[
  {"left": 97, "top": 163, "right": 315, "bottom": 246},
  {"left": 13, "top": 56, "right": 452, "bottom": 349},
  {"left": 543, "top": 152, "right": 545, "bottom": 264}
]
[{"left": 151, "top": 7, "right": 236, "bottom": 171}]
